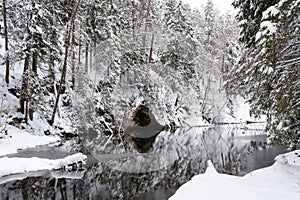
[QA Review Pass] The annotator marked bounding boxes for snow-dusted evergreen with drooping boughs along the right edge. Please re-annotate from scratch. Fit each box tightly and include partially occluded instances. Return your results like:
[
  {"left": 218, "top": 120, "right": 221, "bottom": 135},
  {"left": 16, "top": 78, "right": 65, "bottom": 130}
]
[{"left": 232, "top": 0, "right": 300, "bottom": 147}]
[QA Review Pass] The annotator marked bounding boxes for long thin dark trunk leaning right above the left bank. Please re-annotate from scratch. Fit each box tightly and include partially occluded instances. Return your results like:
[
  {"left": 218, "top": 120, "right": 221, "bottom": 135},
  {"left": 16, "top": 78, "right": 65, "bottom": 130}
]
[{"left": 49, "top": 0, "right": 80, "bottom": 125}]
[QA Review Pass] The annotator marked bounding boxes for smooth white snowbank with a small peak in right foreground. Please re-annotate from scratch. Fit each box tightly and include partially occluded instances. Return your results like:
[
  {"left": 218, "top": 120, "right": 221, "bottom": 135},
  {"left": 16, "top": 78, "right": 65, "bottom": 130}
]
[{"left": 170, "top": 150, "right": 300, "bottom": 200}]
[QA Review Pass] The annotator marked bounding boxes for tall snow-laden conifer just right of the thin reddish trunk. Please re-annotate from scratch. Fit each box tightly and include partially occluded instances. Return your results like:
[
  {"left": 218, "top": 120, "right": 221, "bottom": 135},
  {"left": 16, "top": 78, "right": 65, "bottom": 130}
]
[{"left": 160, "top": 0, "right": 198, "bottom": 124}]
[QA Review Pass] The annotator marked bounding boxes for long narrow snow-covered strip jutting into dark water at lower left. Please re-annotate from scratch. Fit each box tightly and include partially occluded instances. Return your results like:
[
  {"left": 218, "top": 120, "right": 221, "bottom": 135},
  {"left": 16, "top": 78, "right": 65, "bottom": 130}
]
[{"left": 0, "top": 153, "right": 87, "bottom": 177}]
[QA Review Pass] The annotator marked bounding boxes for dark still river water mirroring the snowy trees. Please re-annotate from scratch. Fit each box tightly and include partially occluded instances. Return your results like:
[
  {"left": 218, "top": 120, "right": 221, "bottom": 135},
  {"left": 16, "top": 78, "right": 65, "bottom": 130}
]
[{"left": 0, "top": 126, "right": 286, "bottom": 200}]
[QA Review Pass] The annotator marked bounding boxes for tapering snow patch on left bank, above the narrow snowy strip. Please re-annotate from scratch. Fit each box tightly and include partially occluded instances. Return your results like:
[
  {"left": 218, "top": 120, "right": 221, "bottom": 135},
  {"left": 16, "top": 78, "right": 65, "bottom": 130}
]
[{"left": 0, "top": 125, "right": 60, "bottom": 156}]
